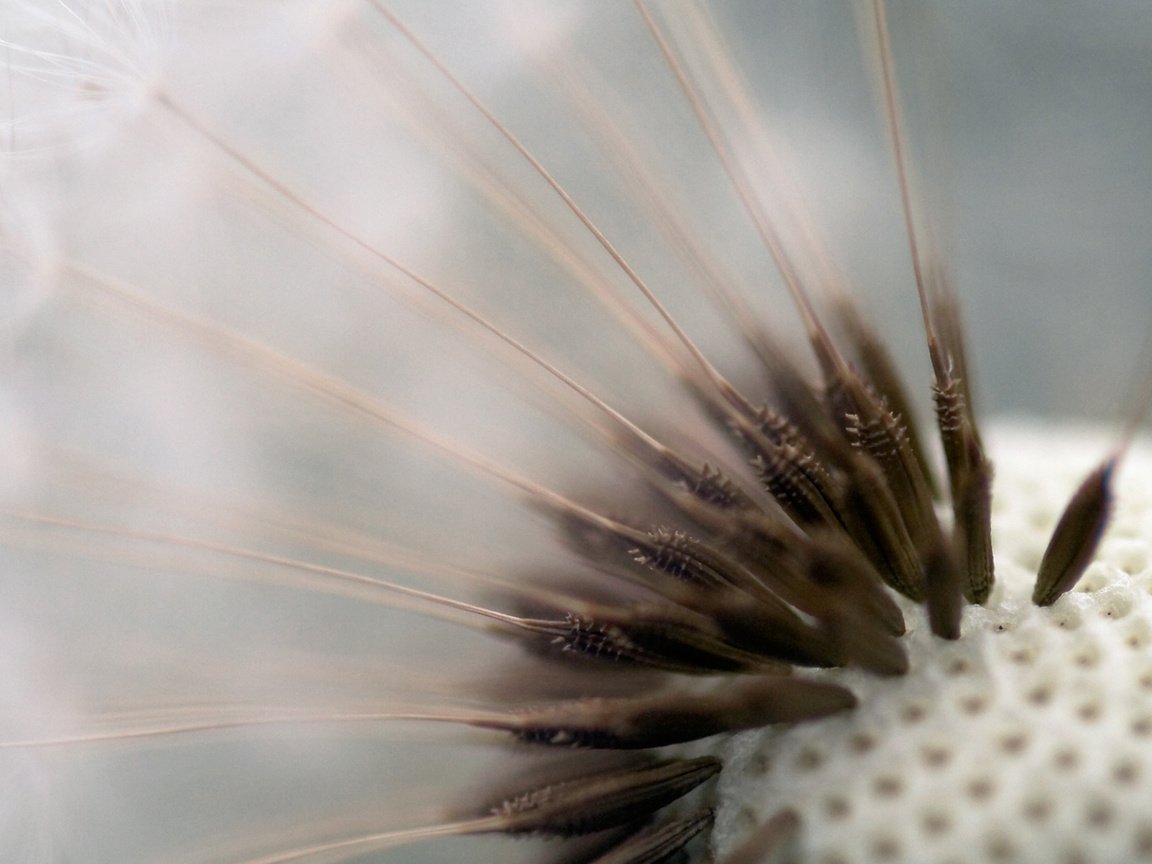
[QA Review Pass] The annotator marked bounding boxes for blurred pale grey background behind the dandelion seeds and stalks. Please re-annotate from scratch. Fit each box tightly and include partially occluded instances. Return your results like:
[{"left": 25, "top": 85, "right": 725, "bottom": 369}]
[{"left": 0, "top": 0, "right": 1152, "bottom": 862}]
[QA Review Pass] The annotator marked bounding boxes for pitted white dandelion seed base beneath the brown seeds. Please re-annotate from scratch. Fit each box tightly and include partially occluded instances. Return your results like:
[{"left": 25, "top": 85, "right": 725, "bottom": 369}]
[{"left": 715, "top": 427, "right": 1152, "bottom": 864}]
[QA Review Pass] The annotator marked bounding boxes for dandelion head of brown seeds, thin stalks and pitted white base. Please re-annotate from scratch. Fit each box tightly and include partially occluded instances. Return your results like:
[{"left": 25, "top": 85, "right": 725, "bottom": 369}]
[{"left": 6, "top": 0, "right": 1152, "bottom": 864}]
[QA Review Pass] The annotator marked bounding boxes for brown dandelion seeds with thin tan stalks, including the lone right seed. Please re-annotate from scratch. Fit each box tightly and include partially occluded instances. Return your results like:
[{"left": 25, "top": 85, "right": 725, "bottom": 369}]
[{"left": 0, "top": 0, "right": 1152, "bottom": 864}]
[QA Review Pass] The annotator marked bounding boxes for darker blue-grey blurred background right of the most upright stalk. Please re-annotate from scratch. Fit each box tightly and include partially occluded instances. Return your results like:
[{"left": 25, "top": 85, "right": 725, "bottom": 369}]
[{"left": 717, "top": 0, "right": 1152, "bottom": 420}]
